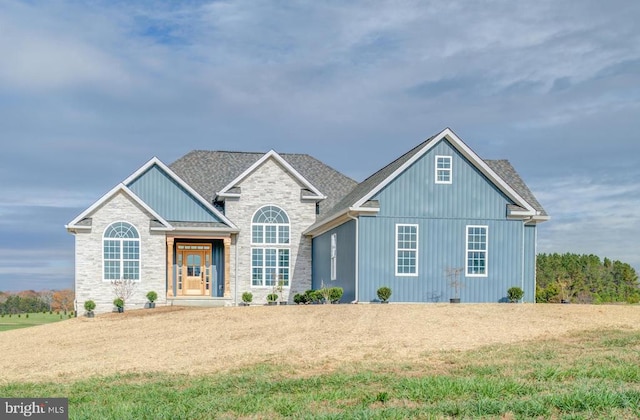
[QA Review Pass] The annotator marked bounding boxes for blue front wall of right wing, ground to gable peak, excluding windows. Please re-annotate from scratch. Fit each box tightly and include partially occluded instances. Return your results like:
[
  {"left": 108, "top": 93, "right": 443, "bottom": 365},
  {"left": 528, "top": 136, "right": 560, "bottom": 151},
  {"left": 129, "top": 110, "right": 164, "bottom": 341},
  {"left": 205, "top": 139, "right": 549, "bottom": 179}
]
[{"left": 358, "top": 140, "right": 535, "bottom": 302}]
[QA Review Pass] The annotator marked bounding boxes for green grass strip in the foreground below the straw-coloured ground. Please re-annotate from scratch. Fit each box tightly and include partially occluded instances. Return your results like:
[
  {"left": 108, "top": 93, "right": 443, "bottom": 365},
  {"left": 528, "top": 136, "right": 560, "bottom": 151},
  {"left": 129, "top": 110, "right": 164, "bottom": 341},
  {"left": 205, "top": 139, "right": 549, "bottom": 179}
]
[{"left": 0, "top": 330, "right": 640, "bottom": 419}]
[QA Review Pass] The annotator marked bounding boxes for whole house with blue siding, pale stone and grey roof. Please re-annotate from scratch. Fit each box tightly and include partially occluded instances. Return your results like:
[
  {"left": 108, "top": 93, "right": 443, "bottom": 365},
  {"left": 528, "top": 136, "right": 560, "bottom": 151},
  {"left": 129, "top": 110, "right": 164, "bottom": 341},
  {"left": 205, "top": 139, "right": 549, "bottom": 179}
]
[{"left": 66, "top": 129, "right": 548, "bottom": 312}]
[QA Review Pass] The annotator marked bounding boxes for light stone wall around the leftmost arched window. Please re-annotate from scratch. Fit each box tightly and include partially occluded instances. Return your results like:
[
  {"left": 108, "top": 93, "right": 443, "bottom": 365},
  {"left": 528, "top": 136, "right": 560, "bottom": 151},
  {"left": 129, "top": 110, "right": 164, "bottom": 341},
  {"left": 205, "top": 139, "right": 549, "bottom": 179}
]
[{"left": 75, "top": 193, "right": 166, "bottom": 314}]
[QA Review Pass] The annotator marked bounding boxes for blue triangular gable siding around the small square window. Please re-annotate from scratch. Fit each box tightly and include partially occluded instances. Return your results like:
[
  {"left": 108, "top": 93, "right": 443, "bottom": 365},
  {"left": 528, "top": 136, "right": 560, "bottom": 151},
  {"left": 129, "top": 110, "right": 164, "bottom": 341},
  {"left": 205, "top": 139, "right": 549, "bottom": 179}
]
[{"left": 373, "top": 139, "right": 512, "bottom": 220}]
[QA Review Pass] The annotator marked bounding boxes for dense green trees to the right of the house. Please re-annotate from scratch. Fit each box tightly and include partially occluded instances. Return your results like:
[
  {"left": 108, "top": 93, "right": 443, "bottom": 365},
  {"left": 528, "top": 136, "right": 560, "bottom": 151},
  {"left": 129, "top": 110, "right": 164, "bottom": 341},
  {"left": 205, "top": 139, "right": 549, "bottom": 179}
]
[{"left": 536, "top": 253, "right": 640, "bottom": 303}]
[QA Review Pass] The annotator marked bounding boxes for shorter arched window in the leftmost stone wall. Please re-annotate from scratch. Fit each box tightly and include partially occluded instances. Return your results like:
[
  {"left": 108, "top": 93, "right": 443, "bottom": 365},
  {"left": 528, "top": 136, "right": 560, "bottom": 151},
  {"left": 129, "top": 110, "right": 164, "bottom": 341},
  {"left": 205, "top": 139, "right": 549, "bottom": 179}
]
[{"left": 102, "top": 222, "right": 140, "bottom": 280}]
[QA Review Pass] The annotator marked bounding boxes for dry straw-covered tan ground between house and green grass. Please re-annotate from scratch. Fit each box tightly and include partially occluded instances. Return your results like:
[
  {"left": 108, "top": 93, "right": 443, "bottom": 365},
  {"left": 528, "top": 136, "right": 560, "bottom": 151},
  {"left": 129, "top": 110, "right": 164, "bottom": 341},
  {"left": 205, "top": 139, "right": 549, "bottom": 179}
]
[{"left": 0, "top": 304, "right": 640, "bottom": 383}]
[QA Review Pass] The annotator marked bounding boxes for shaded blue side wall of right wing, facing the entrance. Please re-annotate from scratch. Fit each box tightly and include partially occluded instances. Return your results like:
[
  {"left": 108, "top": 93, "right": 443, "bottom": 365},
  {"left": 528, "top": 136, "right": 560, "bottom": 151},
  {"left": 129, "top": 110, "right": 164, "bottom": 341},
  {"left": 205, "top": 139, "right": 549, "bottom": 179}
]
[{"left": 311, "top": 220, "right": 356, "bottom": 303}]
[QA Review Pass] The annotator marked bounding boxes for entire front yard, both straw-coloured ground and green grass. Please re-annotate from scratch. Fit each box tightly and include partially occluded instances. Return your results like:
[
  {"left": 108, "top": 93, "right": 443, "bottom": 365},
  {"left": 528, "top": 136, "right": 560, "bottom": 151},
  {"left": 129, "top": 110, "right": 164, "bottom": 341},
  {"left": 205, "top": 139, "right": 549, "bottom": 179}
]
[{"left": 0, "top": 304, "right": 640, "bottom": 419}]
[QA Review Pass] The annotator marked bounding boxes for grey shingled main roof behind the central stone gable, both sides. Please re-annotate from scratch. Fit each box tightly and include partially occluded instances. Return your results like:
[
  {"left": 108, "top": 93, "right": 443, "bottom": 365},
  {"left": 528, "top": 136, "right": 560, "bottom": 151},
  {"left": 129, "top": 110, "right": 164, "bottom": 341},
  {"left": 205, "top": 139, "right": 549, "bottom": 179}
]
[{"left": 169, "top": 150, "right": 357, "bottom": 214}]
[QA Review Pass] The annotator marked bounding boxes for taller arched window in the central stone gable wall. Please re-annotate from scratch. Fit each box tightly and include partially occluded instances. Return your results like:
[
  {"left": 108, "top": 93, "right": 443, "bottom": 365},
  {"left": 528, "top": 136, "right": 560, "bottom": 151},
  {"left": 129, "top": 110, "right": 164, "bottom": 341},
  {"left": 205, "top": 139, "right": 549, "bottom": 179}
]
[{"left": 251, "top": 206, "right": 289, "bottom": 287}]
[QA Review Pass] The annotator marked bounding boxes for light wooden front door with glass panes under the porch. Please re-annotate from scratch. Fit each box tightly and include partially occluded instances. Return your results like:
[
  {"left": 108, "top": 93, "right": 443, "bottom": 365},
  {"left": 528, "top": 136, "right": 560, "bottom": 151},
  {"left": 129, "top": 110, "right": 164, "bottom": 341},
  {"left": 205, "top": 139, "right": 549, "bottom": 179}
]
[{"left": 178, "top": 244, "right": 211, "bottom": 296}]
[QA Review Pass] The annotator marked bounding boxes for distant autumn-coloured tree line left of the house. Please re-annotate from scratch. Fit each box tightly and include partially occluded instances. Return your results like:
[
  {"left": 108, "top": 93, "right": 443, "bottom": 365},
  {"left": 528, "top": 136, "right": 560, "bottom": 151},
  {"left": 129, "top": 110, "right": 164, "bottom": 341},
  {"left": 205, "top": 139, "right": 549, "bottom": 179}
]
[{"left": 0, "top": 289, "right": 75, "bottom": 314}]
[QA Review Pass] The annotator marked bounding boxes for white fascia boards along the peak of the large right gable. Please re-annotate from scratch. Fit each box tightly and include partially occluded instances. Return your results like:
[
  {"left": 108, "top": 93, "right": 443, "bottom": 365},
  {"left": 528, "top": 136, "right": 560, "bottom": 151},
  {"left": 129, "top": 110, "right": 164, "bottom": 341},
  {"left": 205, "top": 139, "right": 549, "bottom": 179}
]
[{"left": 354, "top": 128, "right": 535, "bottom": 214}]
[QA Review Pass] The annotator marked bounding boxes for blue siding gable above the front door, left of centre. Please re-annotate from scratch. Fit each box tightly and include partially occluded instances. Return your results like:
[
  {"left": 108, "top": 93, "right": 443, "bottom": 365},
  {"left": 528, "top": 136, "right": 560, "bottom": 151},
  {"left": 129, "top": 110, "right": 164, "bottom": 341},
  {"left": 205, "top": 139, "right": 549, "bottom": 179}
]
[{"left": 127, "top": 165, "right": 224, "bottom": 223}]
